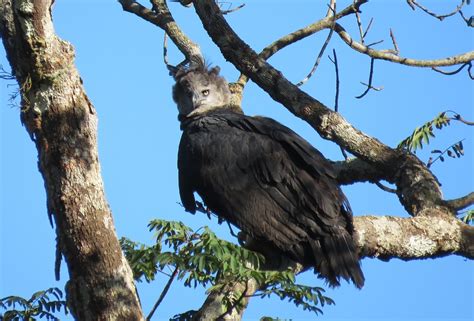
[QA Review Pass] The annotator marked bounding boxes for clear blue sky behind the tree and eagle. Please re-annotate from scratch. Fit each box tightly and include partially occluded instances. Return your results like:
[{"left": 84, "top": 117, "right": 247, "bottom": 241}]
[{"left": 0, "top": 0, "right": 474, "bottom": 321}]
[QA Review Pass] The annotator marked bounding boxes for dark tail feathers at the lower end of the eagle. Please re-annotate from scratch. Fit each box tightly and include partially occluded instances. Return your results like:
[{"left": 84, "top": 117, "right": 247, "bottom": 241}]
[{"left": 312, "top": 231, "right": 365, "bottom": 289}]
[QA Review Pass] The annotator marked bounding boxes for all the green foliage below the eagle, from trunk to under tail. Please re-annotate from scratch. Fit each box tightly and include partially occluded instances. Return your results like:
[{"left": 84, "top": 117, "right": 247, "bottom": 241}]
[{"left": 121, "top": 220, "right": 334, "bottom": 314}]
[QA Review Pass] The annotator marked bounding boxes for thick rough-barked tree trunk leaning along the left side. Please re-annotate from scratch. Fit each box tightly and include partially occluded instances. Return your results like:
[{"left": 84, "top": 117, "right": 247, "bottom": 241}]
[{"left": 0, "top": 0, "right": 143, "bottom": 320}]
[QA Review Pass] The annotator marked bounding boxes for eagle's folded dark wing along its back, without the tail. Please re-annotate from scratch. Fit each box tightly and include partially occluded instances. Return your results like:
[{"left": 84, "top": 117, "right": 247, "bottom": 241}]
[{"left": 229, "top": 117, "right": 352, "bottom": 228}]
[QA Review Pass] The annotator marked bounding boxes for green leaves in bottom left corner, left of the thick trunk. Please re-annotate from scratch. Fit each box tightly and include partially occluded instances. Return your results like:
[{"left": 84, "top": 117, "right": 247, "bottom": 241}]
[{"left": 0, "top": 288, "right": 68, "bottom": 321}]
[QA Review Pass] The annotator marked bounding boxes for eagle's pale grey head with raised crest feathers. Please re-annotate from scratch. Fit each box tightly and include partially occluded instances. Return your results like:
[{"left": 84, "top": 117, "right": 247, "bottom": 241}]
[{"left": 173, "top": 67, "right": 231, "bottom": 117}]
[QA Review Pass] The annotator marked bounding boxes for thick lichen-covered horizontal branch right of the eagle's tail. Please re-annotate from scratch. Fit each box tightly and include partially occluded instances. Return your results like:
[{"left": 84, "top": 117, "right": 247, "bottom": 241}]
[{"left": 354, "top": 209, "right": 474, "bottom": 260}]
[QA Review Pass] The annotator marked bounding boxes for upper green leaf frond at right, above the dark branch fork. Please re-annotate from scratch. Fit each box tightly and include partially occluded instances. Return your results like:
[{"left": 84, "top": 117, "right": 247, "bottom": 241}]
[{"left": 397, "top": 112, "right": 451, "bottom": 152}]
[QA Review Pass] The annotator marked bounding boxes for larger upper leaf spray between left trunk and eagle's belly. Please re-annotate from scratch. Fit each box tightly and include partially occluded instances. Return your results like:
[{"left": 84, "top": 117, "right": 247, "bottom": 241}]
[{"left": 120, "top": 220, "right": 263, "bottom": 287}]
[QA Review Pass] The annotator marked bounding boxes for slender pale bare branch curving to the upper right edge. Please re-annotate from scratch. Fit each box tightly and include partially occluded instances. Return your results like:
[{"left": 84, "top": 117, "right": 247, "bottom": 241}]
[{"left": 334, "top": 23, "right": 474, "bottom": 67}]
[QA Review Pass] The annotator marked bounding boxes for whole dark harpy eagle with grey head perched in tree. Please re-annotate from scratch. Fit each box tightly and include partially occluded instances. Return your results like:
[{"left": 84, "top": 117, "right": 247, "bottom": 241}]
[{"left": 172, "top": 66, "right": 364, "bottom": 288}]
